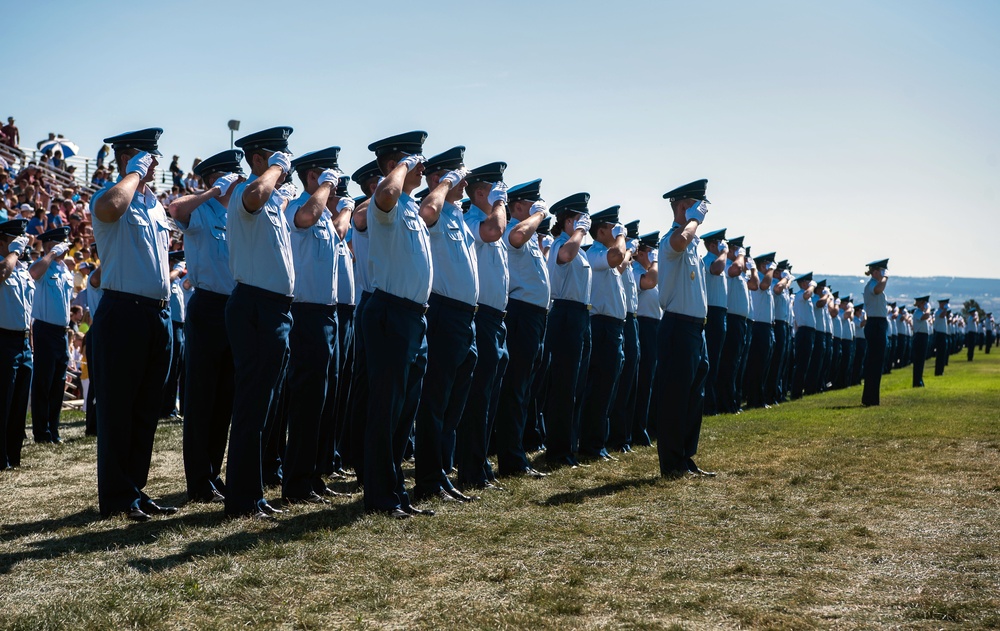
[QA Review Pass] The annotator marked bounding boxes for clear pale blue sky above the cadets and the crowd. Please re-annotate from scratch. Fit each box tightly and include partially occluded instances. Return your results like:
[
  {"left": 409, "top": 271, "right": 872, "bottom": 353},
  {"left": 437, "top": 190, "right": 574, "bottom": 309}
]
[{"left": 7, "top": 0, "right": 1000, "bottom": 278}]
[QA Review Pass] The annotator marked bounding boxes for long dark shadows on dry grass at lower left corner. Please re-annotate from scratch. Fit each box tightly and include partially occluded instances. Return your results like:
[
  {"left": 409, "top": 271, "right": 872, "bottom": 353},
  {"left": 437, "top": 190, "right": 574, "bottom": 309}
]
[{"left": 0, "top": 499, "right": 365, "bottom": 574}]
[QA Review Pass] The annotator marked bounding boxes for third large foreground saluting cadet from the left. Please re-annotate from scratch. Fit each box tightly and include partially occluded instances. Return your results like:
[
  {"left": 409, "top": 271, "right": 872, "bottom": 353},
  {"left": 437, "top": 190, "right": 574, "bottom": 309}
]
[{"left": 225, "top": 127, "right": 295, "bottom": 519}]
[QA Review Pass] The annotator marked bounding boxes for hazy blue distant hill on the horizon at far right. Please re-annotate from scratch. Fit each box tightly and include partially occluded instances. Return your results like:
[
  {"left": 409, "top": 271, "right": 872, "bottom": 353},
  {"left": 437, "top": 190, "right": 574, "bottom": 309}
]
[{"left": 813, "top": 272, "right": 1000, "bottom": 319}]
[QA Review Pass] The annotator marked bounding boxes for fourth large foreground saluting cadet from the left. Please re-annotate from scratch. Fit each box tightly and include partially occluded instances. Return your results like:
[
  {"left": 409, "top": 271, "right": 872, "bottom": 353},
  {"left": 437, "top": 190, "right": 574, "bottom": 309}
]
[{"left": 281, "top": 147, "right": 353, "bottom": 504}]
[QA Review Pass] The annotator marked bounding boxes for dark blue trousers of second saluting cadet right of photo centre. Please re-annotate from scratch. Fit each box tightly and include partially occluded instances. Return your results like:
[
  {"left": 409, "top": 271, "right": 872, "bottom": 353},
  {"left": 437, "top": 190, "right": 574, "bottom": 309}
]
[{"left": 543, "top": 300, "right": 590, "bottom": 466}]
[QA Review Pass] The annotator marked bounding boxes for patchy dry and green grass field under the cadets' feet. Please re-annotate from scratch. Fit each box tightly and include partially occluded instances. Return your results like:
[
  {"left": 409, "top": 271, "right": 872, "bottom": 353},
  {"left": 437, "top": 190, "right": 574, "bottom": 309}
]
[{"left": 0, "top": 352, "right": 1000, "bottom": 629}]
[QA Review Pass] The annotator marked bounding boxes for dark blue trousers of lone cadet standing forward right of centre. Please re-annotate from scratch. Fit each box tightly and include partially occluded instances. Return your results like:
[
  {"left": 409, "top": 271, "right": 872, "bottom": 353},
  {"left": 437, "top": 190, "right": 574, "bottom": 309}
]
[{"left": 655, "top": 312, "right": 708, "bottom": 475}]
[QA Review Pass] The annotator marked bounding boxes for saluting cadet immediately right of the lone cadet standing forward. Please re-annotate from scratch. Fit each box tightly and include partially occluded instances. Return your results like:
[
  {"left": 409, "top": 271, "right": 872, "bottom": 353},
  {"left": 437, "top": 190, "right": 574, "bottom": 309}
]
[{"left": 701, "top": 228, "right": 730, "bottom": 416}]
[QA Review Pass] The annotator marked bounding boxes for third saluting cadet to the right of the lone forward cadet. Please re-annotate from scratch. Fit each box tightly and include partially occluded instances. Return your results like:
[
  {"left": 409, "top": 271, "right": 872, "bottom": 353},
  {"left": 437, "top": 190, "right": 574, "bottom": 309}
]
[{"left": 743, "top": 252, "right": 777, "bottom": 408}]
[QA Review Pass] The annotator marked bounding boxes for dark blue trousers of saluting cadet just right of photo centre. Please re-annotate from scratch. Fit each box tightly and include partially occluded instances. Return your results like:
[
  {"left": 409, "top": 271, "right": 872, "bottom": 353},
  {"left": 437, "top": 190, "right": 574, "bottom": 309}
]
[{"left": 493, "top": 300, "right": 547, "bottom": 475}]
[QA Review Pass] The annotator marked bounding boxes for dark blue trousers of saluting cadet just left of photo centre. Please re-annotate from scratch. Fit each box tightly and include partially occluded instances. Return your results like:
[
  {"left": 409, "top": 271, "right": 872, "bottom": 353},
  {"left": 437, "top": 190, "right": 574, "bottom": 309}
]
[{"left": 455, "top": 305, "right": 509, "bottom": 486}]
